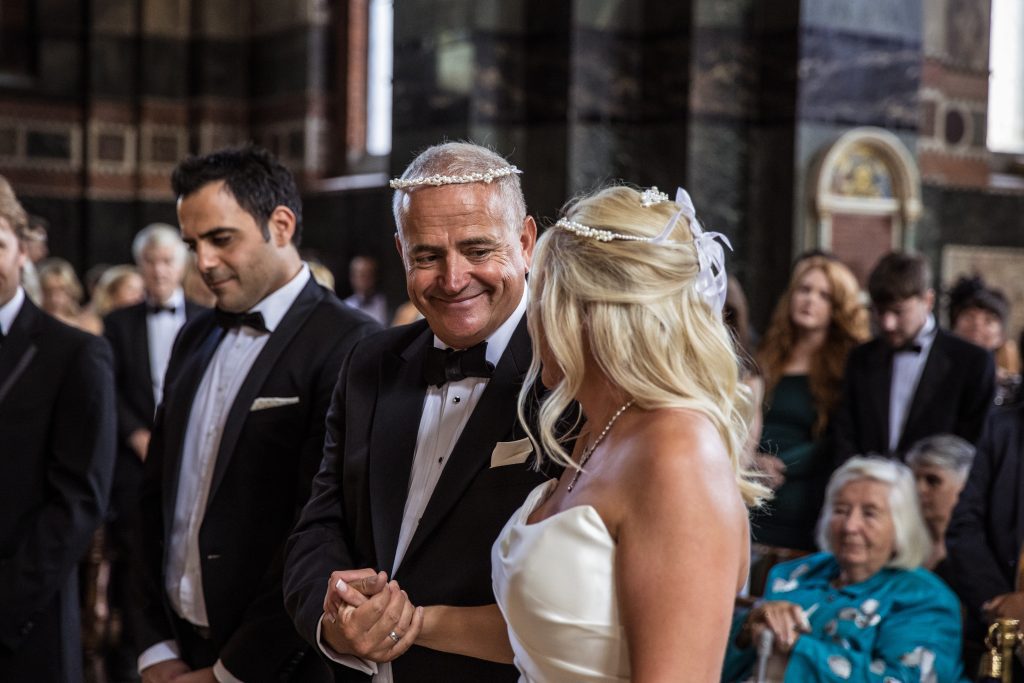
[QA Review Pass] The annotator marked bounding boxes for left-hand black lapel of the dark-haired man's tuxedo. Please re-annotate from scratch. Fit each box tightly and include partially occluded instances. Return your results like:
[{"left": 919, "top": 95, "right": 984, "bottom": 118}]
[{"left": 163, "top": 315, "right": 224, "bottom": 524}]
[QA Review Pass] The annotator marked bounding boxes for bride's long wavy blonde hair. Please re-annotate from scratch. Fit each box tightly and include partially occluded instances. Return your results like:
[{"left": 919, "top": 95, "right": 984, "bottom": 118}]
[{"left": 519, "top": 185, "right": 770, "bottom": 506}]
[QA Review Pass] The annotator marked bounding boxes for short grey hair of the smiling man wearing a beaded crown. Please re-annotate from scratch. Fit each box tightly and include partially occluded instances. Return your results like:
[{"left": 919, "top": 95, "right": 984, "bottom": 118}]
[{"left": 391, "top": 142, "right": 526, "bottom": 239}]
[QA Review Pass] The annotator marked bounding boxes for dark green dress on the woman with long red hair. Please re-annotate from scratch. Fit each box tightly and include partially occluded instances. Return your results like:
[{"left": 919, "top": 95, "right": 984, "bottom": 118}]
[{"left": 752, "top": 375, "right": 829, "bottom": 550}]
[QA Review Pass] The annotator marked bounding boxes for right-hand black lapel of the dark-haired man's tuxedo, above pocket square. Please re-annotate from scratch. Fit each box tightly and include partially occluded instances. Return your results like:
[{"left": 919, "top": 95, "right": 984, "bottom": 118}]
[{"left": 207, "top": 278, "right": 324, "bottom": 501}]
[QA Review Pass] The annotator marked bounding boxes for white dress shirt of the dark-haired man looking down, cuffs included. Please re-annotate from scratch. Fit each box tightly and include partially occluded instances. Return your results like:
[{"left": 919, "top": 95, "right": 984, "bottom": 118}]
[{"left": 138, "top": 263, "right": 310, "bottom": 683}]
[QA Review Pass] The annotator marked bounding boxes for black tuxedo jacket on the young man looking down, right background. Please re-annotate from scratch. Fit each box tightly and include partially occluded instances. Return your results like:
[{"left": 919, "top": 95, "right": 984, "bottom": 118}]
[{"left": 835, "top": 329, "right": 995, "bottom": 463}]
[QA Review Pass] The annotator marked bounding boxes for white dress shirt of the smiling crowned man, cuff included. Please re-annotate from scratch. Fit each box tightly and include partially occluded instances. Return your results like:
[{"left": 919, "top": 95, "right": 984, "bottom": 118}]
[{"left": 316, "top": 289, "right": 528, "bottom": 683}]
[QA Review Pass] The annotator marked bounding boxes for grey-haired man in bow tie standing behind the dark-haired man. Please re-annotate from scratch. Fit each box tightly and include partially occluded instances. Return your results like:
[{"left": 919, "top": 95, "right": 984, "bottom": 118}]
[{"left": 103, "top": 223, "right": 203, "bottom": 680}]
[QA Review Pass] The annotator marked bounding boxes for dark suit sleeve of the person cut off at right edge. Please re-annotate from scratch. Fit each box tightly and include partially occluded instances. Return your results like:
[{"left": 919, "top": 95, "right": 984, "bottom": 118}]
[{"left": 946, "top": 411, "right": 1020, "bottom": 634}]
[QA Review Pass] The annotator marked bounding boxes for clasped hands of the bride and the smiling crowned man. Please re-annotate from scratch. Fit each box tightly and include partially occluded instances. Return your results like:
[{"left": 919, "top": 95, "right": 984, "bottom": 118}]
[{"left": 321, "top": 568, "right": 423, "bottom": 663}]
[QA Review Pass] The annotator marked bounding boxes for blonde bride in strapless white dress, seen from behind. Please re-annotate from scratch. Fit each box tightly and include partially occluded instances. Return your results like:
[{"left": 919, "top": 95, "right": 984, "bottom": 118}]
[{"left": 492, "top": 186, "right": 766, "bottom": 682}]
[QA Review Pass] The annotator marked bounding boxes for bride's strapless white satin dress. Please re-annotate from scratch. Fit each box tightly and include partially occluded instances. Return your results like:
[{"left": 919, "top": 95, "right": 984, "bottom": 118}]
[{"left": 490, "top": 480, "right": 630, "bottom": 683}]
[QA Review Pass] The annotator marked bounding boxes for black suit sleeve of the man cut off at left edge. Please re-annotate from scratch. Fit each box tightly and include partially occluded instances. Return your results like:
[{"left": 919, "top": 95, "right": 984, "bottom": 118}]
[{"left": 0, "top": 336, "right": 116, "bottom": 647}]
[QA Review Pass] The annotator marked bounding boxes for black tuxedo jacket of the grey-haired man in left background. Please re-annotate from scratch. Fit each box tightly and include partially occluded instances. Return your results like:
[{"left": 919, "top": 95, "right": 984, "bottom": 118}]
[{"left": 103, "top": 301, "right": 204, "bottom": 448}]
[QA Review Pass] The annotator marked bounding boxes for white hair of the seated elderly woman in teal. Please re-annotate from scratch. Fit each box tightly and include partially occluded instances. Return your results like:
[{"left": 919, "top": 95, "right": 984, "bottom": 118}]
[{"left": 817, "top": 456, "right": 932, "bottom": 569}]
